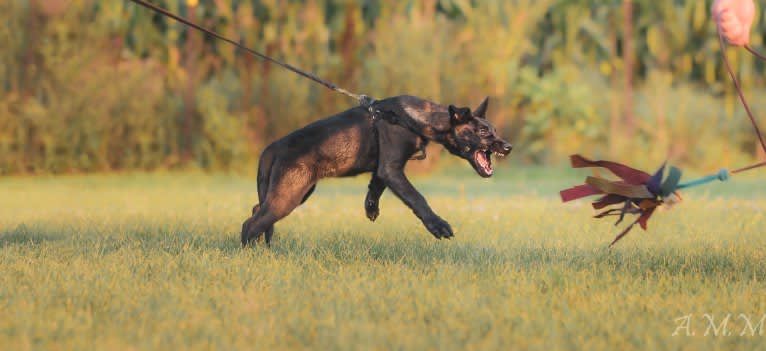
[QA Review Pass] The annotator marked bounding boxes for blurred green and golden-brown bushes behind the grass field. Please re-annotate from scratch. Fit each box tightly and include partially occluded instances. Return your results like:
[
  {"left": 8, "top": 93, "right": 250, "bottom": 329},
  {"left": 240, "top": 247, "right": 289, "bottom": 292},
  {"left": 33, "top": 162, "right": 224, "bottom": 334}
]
[{"left": 0, "top": 0, "right": 766, "bottom": 174}]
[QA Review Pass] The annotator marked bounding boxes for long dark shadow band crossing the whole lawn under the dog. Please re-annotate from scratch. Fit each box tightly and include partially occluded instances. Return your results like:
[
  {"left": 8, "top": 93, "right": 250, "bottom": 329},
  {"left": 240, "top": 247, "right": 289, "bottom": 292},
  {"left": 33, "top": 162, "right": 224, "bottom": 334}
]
[{"left": 0, "top": 223, "right": 766, "bottom": 282}]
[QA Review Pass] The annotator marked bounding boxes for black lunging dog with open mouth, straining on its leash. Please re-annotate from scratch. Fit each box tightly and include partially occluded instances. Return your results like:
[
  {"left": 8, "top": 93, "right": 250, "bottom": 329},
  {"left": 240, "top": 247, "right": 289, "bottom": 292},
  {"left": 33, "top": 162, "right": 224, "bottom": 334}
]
[{"left": 241, "top": 96, "right": 512, "bottom": 246}]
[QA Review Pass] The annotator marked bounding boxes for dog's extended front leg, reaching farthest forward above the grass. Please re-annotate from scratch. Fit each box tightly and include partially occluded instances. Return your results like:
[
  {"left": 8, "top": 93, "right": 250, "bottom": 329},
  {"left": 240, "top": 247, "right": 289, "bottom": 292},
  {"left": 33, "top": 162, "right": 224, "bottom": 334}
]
[{"left": 377, "top": 165, "right": 453, "bottom": 239}]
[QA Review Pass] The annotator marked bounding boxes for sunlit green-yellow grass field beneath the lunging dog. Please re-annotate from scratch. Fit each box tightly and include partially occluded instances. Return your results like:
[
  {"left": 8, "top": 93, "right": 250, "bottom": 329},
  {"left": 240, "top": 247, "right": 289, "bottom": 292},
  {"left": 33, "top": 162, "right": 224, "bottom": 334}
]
[{"left": 0, "top": 167, "right": 766, "bottom": 350}]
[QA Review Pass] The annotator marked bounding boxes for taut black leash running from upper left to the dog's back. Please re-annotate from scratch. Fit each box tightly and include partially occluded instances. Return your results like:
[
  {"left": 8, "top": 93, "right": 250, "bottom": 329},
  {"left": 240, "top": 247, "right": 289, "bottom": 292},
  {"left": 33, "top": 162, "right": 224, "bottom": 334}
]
[{"left": 124, "top": 0, "right": 377, "bottom": 109}]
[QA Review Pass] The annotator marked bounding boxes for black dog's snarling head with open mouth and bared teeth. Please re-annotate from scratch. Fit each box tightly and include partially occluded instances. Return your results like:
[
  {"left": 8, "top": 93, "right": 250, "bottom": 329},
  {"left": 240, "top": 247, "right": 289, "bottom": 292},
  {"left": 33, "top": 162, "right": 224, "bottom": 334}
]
[{"left": 444, "top": 98, "right": 513, "bottom": 178}]
